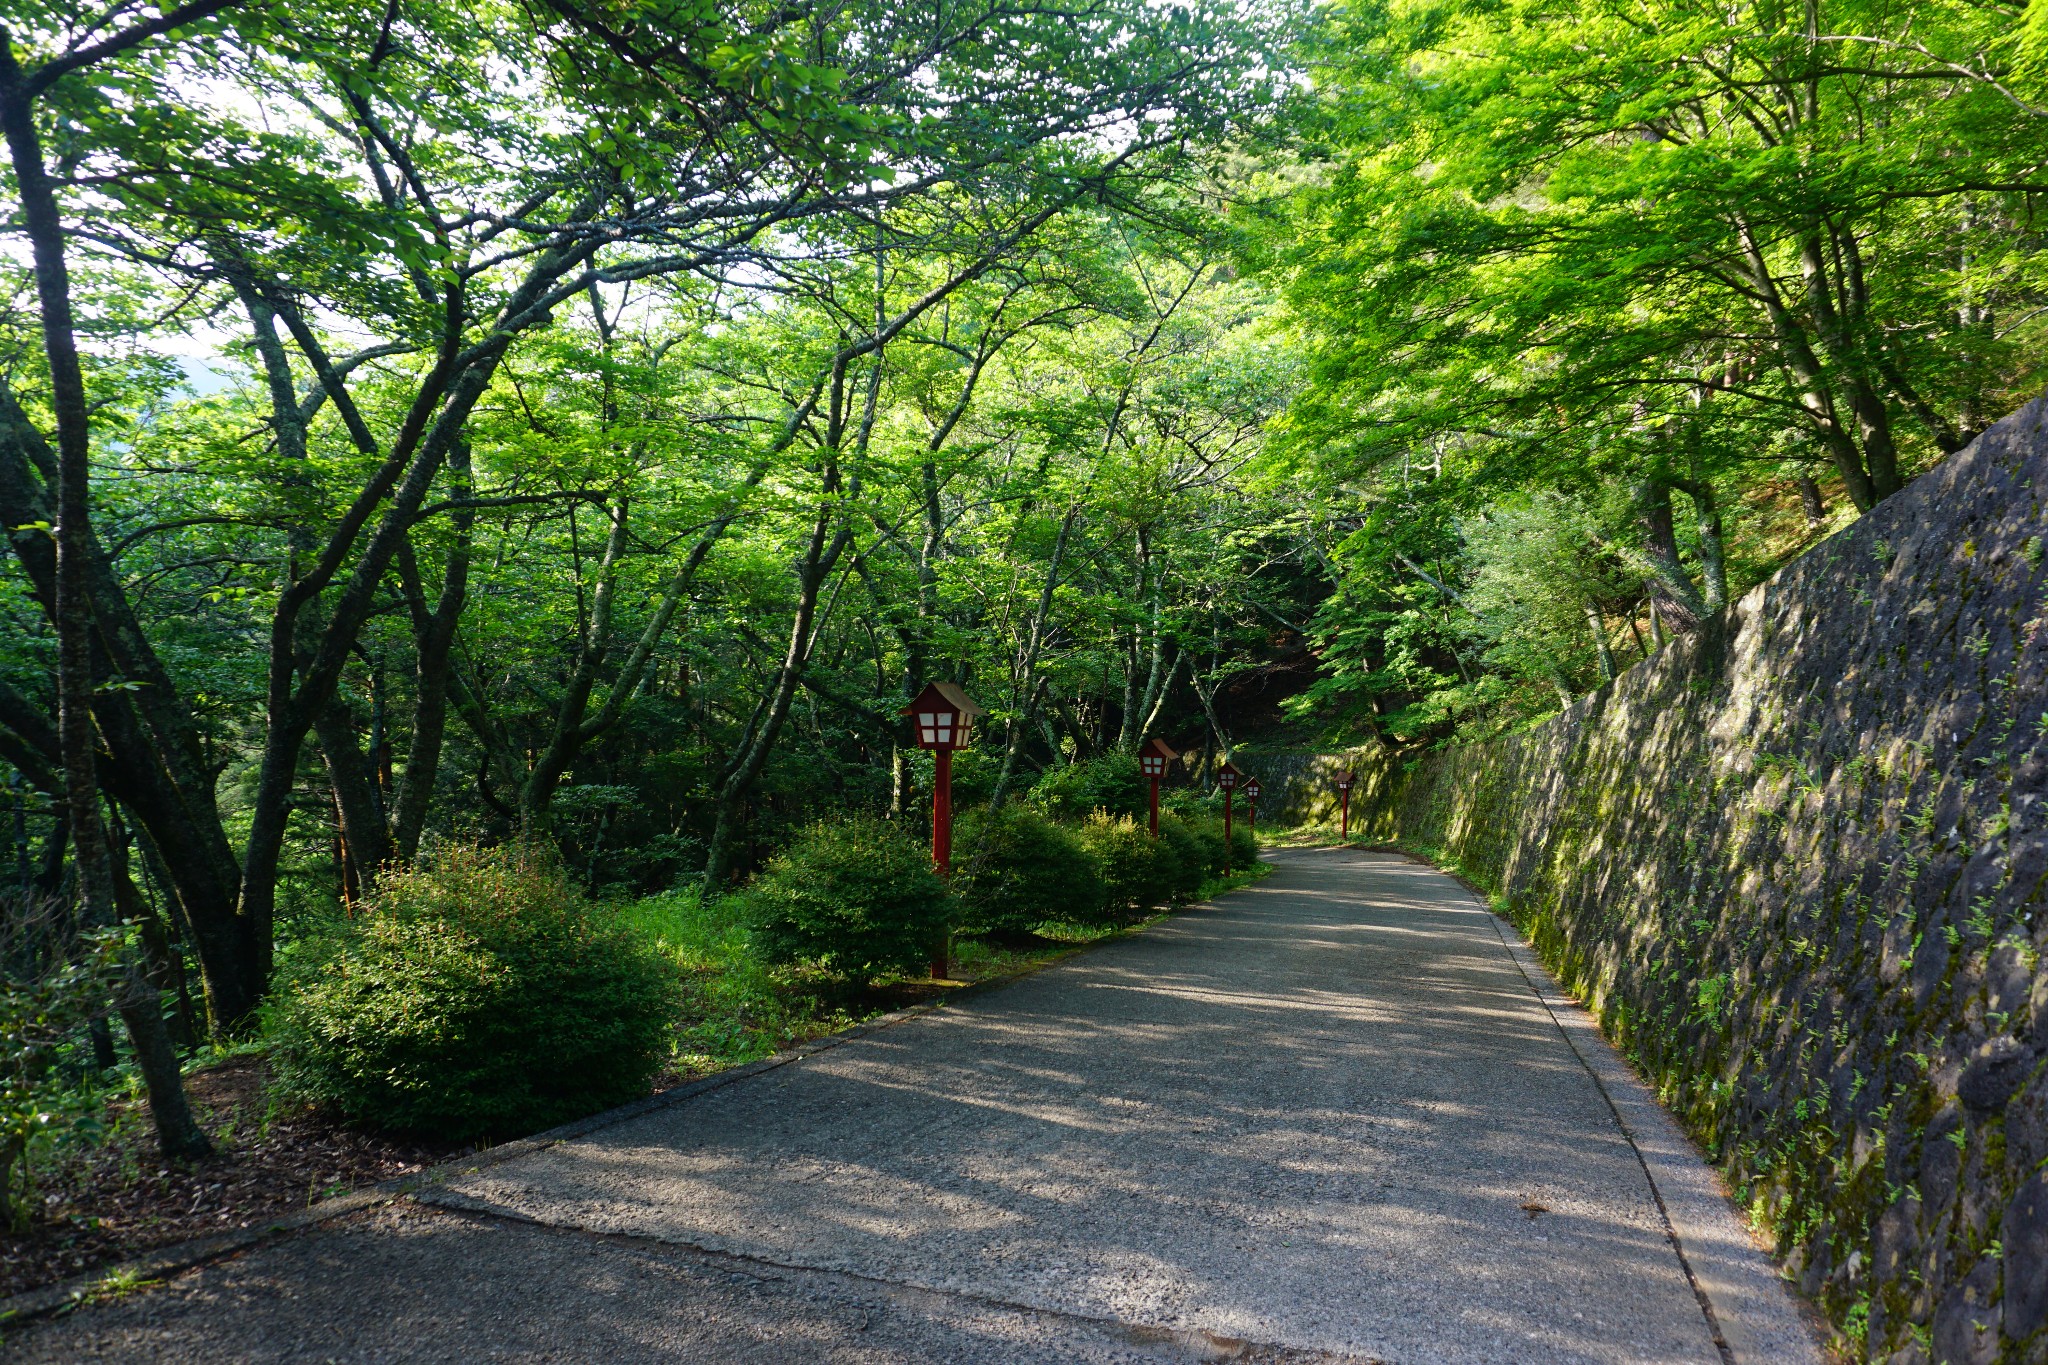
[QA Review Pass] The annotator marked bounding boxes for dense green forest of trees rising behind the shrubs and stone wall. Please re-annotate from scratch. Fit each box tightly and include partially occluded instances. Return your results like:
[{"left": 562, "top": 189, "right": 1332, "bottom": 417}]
[{"left": 0, "top": 0, "right": 2048, "bottom": 1129}]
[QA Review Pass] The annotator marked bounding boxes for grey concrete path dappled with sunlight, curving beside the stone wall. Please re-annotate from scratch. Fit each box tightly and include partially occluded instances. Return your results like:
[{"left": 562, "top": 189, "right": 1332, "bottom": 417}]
[{"left": 10, "top": 849, "right": 1819, "bottom": 1365}]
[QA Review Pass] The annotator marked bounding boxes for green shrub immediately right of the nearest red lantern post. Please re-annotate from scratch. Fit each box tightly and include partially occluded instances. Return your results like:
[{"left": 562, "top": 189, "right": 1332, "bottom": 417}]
[{"left": 954, "top": 802, "right": 1104, "bottom": 933}]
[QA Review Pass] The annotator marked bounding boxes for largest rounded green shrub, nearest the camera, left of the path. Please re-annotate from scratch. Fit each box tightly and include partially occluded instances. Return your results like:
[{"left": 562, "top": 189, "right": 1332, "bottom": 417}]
[{"left": 268, "top": 847, "right": 676, "bottom": 1140}]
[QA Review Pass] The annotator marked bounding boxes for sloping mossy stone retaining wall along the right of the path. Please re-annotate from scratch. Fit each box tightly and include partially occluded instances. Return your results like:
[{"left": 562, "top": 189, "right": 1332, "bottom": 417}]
[{"left": 1277, "top": 401, "right": 2048, "bottom": 1365}]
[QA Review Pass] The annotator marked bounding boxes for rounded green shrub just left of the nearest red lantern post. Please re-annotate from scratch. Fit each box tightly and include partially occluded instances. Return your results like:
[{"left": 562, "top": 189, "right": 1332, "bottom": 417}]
[{"left": 748, "top": 819, "right": 956, "bottom": 978}]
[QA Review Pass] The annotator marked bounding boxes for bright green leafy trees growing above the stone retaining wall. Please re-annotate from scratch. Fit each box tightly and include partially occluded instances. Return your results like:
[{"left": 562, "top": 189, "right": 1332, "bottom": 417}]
[{"left": 1255, "top": 0, "right": 2048, "bottom": 739}]
